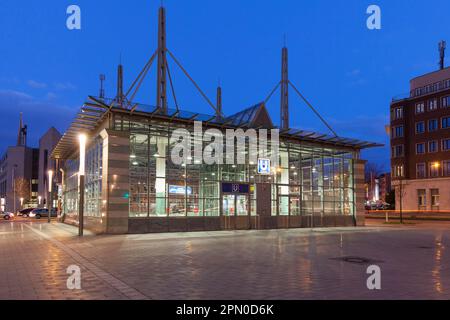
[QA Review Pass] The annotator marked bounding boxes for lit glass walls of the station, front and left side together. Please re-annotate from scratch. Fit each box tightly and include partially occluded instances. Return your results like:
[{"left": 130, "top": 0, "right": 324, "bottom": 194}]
[{"left": 63, "top": 115, "right": 358, "bottom": 229}]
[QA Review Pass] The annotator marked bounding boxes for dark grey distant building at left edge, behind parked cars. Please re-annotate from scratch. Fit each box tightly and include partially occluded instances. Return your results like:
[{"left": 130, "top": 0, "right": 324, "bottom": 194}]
[{"left": 0, "top": 115, "right": 61, "bottom": 212}]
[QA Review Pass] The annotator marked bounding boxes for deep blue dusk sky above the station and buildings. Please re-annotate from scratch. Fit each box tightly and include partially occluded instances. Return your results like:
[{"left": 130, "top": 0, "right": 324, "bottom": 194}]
[{"left": 0, "top": 0, "right": 450, "bottom": 170}]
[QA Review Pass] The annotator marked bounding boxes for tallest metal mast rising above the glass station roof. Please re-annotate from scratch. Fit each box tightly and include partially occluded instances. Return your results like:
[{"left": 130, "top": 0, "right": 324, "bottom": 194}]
[{"left": 156, "top": 7, "right": 167, "bottom": 114}]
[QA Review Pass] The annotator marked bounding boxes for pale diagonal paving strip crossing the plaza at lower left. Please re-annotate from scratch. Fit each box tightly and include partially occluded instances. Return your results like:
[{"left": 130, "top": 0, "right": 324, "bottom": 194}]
[{"left": 24, "top": 224, "right": 150, "bottom": 300}]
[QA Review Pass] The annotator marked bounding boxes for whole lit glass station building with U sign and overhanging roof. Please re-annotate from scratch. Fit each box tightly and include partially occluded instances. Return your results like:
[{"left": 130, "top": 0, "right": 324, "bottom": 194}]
[{"left": 53, "top": 97, "right": 377, "bottom": 234}]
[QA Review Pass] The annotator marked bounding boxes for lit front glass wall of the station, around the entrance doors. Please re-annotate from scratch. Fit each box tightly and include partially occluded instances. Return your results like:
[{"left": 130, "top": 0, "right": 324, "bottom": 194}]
[{"left": 115, "top": 119, "right": 355, "bottom": 218}]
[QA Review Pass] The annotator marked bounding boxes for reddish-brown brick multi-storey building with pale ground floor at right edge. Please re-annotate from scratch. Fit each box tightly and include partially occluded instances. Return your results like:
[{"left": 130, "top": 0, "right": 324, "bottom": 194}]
[{"left": 390, "top": 47, "right": 450, "bottom": 211}]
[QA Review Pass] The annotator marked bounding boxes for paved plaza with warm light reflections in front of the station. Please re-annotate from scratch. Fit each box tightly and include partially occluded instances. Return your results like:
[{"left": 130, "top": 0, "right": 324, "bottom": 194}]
[{"left": 0, "top": 220, "right": 450, "bottom": 300}]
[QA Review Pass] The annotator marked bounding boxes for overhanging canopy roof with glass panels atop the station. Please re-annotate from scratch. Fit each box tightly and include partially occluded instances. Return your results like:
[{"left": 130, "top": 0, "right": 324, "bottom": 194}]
[{"left": 52, "top": 97, "right": 383, "bottom": 159}]
